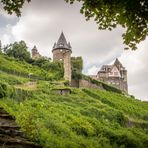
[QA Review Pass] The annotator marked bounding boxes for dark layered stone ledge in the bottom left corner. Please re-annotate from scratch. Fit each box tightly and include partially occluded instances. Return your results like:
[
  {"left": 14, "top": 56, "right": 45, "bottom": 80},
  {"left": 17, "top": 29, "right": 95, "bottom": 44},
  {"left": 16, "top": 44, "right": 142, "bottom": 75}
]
[{"left": 0, "top": 107, "right": 42, "bottom": 148}]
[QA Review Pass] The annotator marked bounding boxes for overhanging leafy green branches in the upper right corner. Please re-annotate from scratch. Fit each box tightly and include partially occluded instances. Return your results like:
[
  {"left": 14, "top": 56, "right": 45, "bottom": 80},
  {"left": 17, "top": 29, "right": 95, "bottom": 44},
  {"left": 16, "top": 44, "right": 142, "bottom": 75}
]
[{"left": 65, "top": 0, "right": 148, "bottom": 50}]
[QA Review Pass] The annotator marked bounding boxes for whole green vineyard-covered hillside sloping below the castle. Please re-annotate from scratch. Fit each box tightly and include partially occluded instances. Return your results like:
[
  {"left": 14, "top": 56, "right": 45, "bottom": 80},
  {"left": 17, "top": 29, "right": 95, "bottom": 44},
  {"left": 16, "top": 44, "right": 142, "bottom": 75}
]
[{"left": 0, "top": 55, "right": 148, "bottom": 148}]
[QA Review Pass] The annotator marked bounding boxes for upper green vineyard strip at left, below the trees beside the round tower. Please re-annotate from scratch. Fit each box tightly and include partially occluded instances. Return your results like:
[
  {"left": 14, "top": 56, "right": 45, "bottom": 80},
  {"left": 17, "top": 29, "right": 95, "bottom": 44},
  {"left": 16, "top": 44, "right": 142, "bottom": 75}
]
[{"left": 0, "top": 55, "right": 55, "bottom": 80}]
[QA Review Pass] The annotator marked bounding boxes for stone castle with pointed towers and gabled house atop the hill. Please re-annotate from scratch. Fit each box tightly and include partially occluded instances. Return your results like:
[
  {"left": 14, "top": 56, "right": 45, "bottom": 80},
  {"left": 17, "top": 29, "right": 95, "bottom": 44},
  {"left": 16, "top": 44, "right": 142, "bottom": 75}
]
[{"left": 32, "top": 32, "right": 128, "bottom": 93}]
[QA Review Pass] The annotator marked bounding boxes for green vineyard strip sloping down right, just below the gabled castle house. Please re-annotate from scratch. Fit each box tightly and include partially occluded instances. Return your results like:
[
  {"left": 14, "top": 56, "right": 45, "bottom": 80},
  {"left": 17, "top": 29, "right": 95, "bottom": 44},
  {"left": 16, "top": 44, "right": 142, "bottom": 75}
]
[{"left": 83, "top": 89, "right": 148, "bottom": 121}]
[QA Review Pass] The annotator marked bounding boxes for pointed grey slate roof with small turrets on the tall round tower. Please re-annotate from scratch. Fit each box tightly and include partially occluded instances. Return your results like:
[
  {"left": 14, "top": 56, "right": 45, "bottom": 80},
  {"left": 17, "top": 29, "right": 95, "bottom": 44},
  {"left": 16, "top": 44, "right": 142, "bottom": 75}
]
[{"left": 53, "top": 32, "right": 71, "bottom": 50}]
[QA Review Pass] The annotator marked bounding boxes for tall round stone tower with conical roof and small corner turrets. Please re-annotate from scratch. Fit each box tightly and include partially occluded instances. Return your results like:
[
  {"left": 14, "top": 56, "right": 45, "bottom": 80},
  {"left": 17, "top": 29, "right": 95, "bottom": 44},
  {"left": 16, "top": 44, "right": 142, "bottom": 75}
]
[{"left": 52, "top": 32, "right": 72, "bottom": 82}]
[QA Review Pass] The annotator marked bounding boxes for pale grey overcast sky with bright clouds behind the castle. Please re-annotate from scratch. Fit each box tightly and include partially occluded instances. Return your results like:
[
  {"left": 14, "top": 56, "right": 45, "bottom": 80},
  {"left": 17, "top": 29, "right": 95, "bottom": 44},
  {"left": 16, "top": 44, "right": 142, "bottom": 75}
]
[{"left": 0, "top": 0, "right": 148, "bottom": 100}]
